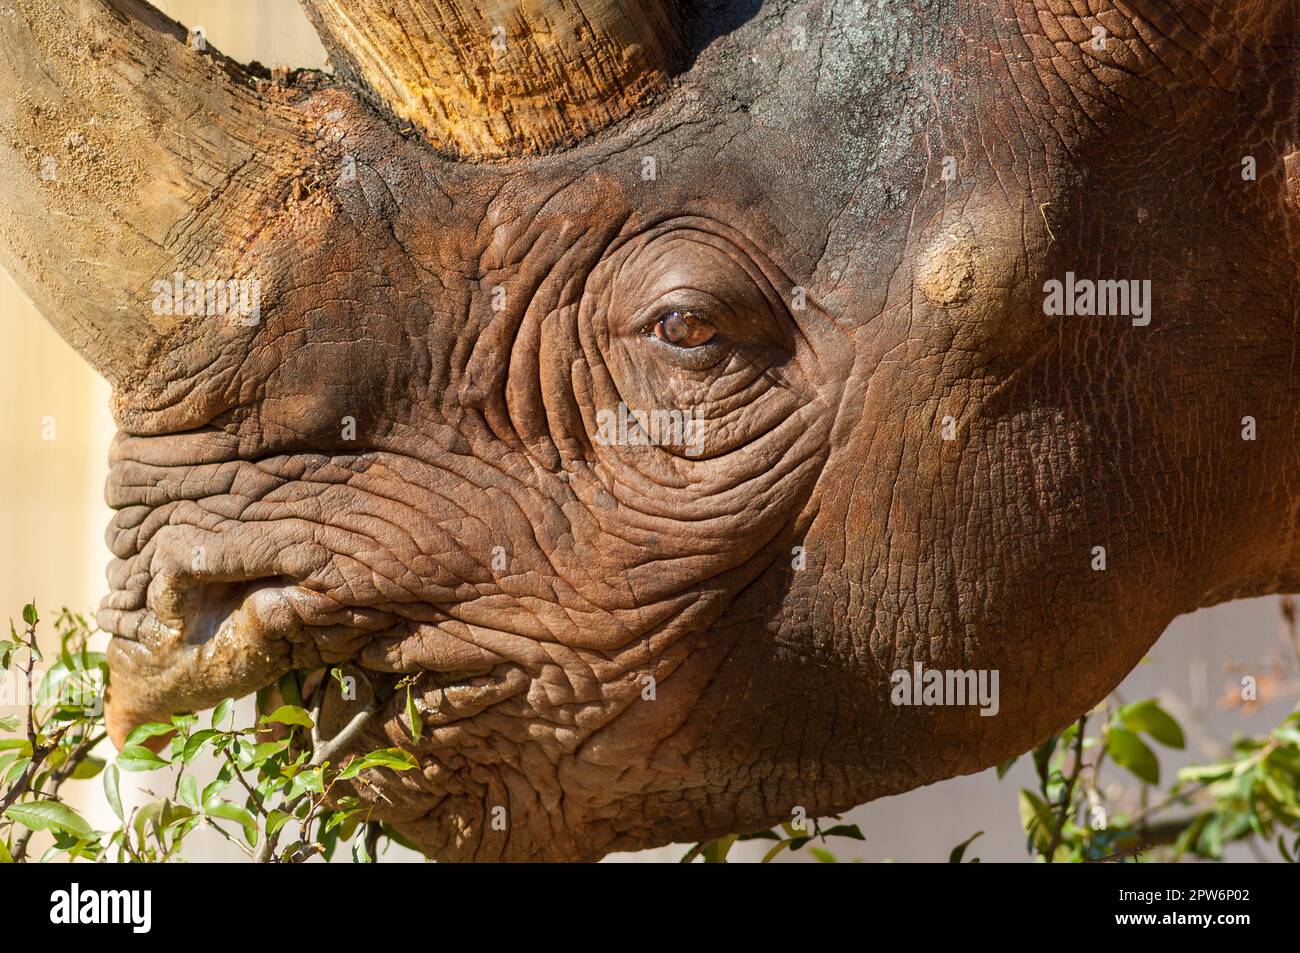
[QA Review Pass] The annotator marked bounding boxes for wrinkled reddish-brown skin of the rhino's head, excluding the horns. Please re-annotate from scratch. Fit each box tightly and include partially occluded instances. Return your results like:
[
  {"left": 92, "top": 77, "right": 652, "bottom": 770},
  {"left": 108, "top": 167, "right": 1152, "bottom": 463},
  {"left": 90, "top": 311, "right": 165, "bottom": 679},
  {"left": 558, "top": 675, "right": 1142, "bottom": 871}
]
[{"left": 0, "top": 0, "right": 1300, "bottom": 859}]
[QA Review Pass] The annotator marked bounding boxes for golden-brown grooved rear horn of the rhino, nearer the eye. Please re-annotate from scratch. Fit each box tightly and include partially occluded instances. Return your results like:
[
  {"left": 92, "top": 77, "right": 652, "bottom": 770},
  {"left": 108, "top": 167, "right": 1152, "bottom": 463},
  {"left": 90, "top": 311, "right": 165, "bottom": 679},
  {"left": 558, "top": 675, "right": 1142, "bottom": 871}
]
[{"left": 303, "top": 0, "right": 685, "bottom": 159}]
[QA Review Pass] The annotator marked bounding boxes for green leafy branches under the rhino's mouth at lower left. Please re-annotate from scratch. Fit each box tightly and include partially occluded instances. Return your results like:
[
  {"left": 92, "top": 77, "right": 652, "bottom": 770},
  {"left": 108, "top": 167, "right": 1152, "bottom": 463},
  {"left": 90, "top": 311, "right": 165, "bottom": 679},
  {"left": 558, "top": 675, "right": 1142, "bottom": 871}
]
[{"left": 0, "top": 606, "right": 417, "bottom": 863}]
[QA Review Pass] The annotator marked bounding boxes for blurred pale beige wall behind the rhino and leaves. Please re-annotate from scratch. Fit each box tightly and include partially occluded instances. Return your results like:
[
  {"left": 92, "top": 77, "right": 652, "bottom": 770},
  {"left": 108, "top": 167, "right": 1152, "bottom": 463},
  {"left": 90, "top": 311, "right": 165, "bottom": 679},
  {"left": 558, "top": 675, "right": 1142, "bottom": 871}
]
[{"left": 0, "top": 0, "right": 1295, "bottom": 862}]
